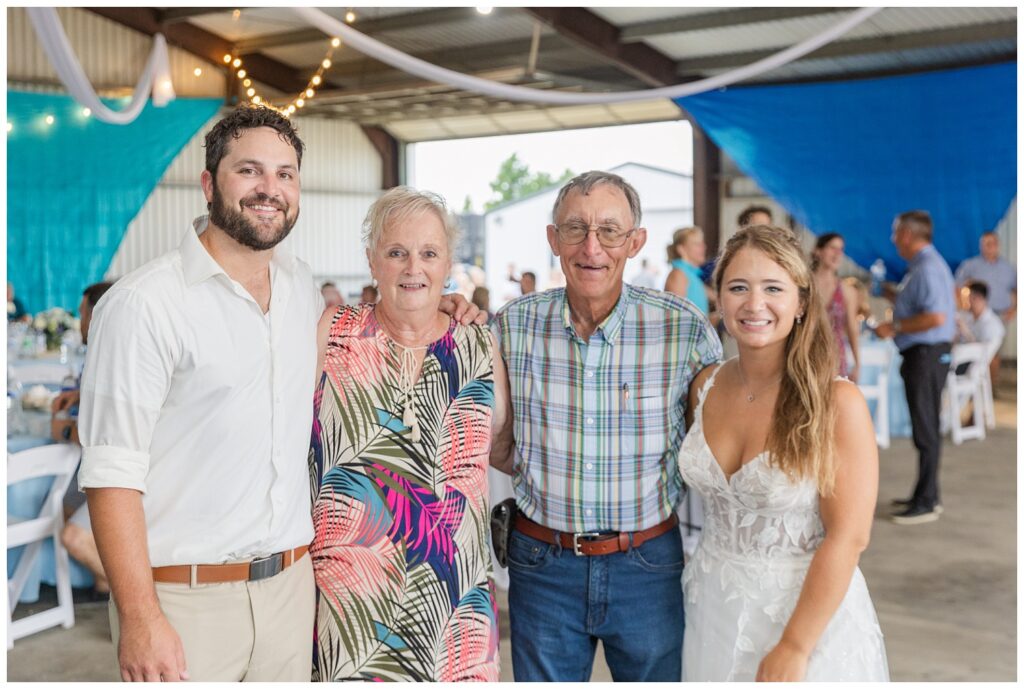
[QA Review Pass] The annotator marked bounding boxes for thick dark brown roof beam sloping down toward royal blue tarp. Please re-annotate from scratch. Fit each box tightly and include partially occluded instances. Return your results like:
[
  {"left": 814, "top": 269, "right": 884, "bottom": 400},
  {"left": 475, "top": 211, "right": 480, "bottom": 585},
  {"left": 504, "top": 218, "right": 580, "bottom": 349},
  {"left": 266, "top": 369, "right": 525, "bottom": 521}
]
[{"left": 524, "top": 7, "right": 677, "bottom": 86}]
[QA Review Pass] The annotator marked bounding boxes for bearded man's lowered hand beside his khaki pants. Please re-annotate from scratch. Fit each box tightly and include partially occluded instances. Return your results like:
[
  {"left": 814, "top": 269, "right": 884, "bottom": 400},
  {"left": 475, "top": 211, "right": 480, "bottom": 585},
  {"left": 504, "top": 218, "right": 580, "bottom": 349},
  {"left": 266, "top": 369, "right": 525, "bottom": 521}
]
[{"left": 118, "top": 611, "right": 188, "bottom": 682}]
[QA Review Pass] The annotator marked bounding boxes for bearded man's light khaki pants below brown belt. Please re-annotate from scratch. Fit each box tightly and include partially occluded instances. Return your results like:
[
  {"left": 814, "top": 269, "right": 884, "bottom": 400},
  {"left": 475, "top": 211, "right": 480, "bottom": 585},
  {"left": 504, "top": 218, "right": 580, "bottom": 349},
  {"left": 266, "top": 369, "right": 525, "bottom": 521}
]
[{"left": 110, "top": 554, "right": 316, "bottom": 682}]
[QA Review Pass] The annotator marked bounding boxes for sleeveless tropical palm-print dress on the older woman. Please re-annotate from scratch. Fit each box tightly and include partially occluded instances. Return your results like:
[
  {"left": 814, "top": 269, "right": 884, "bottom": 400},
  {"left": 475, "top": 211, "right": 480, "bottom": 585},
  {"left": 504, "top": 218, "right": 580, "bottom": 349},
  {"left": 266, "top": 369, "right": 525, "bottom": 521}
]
[{"left": 309, "top": 305, "right": 498, "bottom": 682}]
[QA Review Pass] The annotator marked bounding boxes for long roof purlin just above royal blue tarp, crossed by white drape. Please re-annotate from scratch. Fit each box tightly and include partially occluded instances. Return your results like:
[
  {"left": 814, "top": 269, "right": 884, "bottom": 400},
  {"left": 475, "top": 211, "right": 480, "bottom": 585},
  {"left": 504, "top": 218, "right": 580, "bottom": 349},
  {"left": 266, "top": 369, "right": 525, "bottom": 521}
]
[{"left": 676, "top": 20, "right": 1017, "bottom": 76}]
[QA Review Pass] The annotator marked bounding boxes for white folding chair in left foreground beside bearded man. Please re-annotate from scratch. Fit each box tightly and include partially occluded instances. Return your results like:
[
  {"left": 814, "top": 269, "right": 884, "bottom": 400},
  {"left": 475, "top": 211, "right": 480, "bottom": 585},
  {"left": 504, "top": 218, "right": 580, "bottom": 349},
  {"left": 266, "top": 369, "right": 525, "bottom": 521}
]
[{"left": 7, "top": 444, "right": 82, "bottom": 650}]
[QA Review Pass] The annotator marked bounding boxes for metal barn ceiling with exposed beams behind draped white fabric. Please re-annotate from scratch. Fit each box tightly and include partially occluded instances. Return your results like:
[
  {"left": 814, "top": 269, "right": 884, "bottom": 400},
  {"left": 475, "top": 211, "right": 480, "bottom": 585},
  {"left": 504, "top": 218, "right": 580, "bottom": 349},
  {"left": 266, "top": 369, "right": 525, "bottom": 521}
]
[{"left": 83, "top": 7, "right": 1017, "bottom": 142}]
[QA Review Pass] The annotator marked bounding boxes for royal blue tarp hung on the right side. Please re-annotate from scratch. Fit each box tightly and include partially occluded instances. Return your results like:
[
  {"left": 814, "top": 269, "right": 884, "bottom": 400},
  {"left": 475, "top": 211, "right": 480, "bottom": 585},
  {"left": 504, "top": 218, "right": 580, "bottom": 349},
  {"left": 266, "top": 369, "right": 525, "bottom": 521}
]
[{"left": 677, "top": 62, "right": 1017, "bottom": 278}]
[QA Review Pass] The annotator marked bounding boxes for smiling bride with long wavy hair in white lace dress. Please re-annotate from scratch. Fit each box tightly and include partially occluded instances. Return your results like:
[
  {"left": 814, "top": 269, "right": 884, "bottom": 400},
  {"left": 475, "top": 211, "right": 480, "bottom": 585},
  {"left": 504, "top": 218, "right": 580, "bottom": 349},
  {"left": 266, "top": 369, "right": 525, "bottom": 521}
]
[{"left": 679, "top": 225, "right": 889, "bottom": 682}]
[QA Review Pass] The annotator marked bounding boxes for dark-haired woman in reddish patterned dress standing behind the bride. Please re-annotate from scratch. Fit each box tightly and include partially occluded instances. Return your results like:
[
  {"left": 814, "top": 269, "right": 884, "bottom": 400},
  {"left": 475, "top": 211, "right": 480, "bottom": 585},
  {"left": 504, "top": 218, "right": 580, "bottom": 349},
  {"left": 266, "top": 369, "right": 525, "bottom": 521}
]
[{"left": 811, "top": 232, "right": 860, "bottom": 383}]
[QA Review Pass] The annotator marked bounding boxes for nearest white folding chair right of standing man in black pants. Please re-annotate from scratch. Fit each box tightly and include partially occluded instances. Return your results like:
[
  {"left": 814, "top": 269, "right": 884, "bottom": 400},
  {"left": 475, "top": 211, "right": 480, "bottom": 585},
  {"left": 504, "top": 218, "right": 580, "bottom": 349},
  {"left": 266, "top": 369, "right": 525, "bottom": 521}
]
[{"left": 942, "top": 342, "right": 994, "bottom": 445}]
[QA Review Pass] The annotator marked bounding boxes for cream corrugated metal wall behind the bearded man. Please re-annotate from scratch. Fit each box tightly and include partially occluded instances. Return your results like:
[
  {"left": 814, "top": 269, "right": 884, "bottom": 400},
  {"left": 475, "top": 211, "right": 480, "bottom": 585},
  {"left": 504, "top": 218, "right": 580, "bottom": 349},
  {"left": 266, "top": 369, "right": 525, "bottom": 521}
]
[{"left": 7, "top": 7, "right": 381, "bottom": 293}]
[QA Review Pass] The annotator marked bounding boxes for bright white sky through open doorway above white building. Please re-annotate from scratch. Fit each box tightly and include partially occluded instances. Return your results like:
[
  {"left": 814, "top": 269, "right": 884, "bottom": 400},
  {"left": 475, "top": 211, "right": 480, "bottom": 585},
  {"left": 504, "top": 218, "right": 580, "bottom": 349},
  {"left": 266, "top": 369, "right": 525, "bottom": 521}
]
[{"left": 409, "top": 120, "right": 693, "bottom": 213}]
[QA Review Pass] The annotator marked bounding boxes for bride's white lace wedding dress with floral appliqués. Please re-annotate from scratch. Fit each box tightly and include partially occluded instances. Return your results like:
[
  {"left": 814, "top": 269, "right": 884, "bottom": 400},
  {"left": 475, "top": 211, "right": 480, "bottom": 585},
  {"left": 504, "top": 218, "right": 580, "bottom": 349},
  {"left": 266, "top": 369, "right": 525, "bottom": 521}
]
[{"left": 679, "top": 368, "right": 889, "bottom": 682}]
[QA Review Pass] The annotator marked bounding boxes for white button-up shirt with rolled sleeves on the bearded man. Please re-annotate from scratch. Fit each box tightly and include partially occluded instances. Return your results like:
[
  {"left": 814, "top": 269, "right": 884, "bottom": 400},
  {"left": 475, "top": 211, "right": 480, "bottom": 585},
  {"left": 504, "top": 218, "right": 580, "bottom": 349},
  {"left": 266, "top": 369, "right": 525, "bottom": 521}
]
[{"left": 79, "top": 217, "right": 324, "bottom": 567}]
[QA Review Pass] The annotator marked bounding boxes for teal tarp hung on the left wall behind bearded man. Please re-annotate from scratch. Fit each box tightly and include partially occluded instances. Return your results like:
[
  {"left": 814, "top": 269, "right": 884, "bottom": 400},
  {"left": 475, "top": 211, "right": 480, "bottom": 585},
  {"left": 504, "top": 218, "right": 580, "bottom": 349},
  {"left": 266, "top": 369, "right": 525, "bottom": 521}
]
[{"left": 7, "top": 91, "right": 222, "bottom": 312}]
